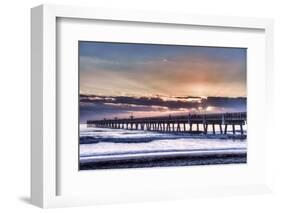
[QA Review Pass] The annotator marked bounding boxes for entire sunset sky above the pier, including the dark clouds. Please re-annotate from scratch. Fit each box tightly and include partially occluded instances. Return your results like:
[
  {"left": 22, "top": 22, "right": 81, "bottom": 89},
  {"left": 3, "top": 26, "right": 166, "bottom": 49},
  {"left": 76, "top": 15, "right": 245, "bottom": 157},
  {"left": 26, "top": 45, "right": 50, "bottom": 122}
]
[{"left": 79, "top": 41, "right": 247, "bottom": 123}]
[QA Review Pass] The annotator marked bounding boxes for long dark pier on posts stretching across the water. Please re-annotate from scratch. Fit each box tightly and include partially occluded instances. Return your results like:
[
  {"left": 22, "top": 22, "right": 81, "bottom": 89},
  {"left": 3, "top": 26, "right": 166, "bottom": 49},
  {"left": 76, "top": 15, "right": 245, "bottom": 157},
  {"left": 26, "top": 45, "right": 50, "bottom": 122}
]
[{"left": 87, "top": 112, "right": 247, "bottom": 135}]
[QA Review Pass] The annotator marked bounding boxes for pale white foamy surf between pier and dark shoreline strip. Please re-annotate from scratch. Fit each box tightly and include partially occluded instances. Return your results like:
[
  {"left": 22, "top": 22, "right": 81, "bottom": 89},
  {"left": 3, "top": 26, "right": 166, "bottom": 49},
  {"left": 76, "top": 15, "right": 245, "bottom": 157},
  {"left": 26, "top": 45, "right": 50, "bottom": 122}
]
[{"left": 80, "top": 127, "right": 247, "bottom": 162}]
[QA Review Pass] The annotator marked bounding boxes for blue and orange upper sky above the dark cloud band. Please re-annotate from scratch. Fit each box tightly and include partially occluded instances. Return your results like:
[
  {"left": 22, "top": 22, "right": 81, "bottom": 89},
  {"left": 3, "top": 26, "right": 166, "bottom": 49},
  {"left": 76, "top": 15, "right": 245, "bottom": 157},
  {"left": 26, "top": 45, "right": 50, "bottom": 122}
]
[{"left": 79, "top": 41, "right": 246, "bottom": 97}]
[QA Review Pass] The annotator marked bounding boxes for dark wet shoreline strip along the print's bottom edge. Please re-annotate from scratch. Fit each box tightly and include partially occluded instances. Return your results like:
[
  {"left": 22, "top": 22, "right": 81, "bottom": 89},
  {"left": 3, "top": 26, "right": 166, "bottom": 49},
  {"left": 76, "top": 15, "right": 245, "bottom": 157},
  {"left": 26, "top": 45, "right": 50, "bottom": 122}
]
[{"left": 79, "top": 150, "right": 247, "bottom": 170}]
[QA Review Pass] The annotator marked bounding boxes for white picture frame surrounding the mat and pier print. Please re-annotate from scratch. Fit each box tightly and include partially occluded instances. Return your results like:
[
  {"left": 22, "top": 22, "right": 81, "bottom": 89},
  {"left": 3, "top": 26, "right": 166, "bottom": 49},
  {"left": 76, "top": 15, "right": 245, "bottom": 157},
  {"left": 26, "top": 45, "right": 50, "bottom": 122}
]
[{"left": 31, "top": 5, "right": 274, "bottom": 208}]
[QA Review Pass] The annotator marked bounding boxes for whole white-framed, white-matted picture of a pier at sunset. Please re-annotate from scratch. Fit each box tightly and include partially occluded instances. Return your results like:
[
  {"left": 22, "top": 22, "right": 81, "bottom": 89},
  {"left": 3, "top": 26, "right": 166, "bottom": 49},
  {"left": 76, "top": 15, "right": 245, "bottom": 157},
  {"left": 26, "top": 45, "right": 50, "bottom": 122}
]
[{"left": 31, "top": 5, "right": 273, "bottom": 207}]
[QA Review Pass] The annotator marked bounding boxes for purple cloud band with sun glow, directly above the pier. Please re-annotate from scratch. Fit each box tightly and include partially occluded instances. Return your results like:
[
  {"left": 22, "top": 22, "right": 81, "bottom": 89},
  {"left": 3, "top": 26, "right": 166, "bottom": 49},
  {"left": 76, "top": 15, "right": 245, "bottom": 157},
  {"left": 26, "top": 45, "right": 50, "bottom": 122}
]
[{"left": 80, "top": 95, "right": 246, "bottom": 123}]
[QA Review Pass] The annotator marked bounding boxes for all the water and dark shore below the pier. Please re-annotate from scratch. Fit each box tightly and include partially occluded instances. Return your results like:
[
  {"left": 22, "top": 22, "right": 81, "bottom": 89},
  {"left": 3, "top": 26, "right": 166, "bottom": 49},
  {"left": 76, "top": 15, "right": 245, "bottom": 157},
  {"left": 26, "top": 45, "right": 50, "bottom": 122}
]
[{"left": 79, "top": 124, "right": 247, "bottom": 170}]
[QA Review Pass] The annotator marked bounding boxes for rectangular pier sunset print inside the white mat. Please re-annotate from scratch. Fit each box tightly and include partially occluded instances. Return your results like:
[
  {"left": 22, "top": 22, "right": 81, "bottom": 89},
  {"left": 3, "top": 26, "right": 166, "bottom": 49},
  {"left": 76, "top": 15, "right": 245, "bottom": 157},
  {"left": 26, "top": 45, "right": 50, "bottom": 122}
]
[{"left": 78, "top": 41, "right": 247, "bottom": 170}]
